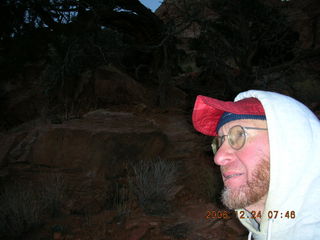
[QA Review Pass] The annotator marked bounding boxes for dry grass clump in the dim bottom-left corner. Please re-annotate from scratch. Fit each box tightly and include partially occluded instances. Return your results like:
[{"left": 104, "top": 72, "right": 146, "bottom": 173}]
[{"left": 0, "top": 174, "right": 64, "bottom": 239}]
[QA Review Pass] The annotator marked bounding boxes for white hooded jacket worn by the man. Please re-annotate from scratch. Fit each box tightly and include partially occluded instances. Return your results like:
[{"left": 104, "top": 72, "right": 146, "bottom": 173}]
[{"left": 235, "top": 90, "right": 320, "bottom": 240}]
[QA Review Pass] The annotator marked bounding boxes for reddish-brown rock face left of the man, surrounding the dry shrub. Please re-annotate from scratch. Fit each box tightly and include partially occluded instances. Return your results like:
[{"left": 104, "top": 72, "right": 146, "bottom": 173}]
[{"left": 0, "top": 110, "right": 245, "bottom": 239}]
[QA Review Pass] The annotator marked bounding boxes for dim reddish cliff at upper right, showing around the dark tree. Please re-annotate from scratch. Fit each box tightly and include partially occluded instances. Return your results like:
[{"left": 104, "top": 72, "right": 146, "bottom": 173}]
[{"left": 156, "top": 0, "right": 320, "bottom": 107}]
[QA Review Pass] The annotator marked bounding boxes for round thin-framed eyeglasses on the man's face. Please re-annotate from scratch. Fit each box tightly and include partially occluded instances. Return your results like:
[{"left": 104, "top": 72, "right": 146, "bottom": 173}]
[{"left": 211, "top": 125, "right": 268, "bottom": 154}]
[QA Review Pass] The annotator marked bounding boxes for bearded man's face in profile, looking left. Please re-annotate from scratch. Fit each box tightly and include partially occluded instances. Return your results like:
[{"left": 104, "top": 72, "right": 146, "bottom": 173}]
[{"left": 214, "top": 119, "right": 270, "bottom": 209}]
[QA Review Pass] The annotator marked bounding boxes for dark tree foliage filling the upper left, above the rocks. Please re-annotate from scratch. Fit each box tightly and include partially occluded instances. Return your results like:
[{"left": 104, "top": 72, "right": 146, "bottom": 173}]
[{"left": 0, "top": 0, "right": 180, "bottom": 125}]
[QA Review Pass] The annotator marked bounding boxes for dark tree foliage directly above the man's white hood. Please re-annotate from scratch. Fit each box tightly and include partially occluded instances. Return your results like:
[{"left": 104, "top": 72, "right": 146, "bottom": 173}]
[{"left": 192, "top": 0, "right": 298, "bottom": 95}]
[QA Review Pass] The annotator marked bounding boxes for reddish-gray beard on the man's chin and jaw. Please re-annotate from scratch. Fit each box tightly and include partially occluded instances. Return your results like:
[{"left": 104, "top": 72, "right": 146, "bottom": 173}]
[{"left": 221, "top": 159, "right": 270, "bottom": 209}]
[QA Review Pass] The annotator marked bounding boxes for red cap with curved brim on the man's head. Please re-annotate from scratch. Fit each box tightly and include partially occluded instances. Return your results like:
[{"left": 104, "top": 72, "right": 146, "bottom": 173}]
[{"left": 192, "top": 95, "right": 265, "bottom": 136}]
